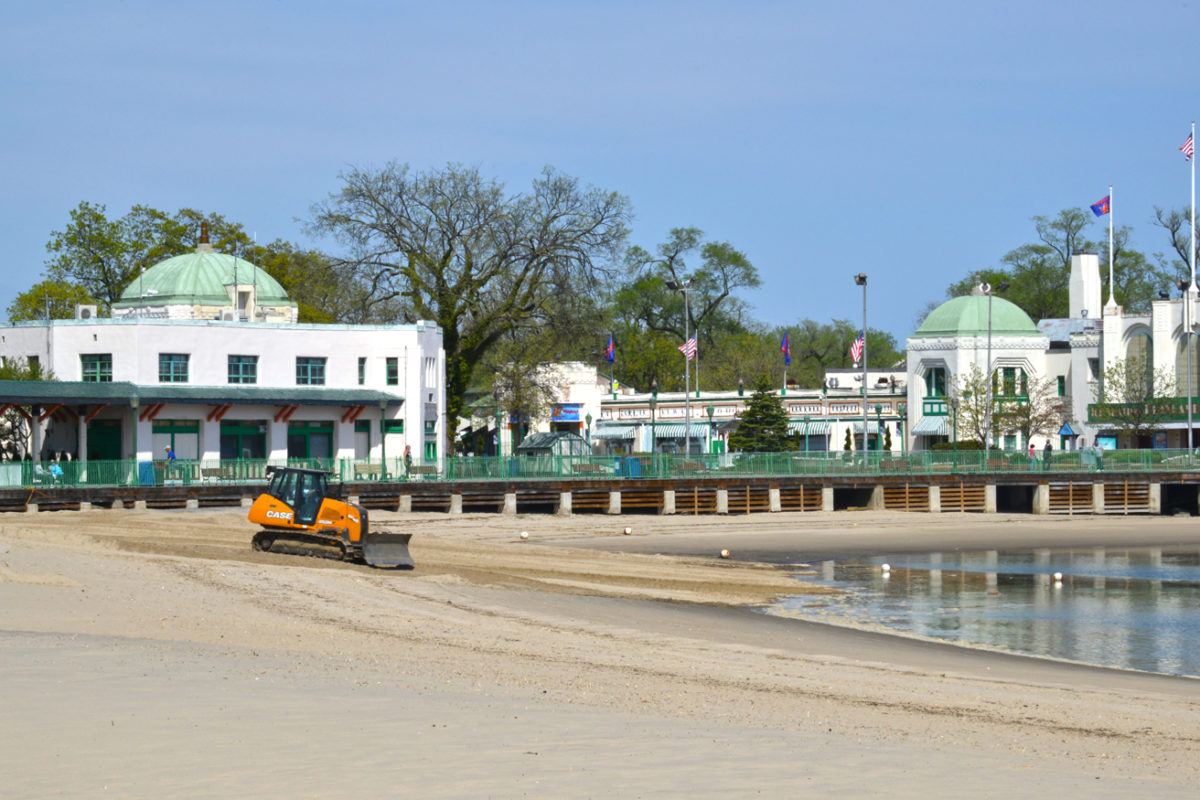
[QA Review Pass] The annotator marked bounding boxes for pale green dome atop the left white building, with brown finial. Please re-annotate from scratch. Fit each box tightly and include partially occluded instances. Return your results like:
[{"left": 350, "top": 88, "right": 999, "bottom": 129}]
[{"left": 113, "top": 245, "right": 295, "bottom": 308}]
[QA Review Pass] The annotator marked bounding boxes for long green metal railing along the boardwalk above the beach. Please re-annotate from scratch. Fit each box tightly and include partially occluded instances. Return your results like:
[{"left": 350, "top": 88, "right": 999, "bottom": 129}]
[{"left": 0, "top": 450, "right": 1200, "bottom": 488}]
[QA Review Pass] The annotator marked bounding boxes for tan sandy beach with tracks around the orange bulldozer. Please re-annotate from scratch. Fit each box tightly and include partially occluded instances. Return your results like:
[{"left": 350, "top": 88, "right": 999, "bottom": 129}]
[{"left": 0, "top": 510, "right": 1200, "bottom": 798}]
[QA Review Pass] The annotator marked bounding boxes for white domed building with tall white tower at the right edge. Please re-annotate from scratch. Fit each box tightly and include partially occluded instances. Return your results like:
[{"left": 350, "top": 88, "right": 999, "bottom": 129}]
[{"left": 907, "top": 253, "right": 1200, "bottom": 450}]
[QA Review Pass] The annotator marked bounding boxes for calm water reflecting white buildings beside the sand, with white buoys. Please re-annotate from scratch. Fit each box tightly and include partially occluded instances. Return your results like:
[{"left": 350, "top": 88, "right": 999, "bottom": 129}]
[{"left": 767, "top": 548, "right": 1200, "bottom": 675}]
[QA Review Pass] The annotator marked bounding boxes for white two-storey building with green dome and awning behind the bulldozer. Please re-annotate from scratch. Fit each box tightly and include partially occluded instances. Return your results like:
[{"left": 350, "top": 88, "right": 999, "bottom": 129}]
[{"left": 0, "top": 227, "right": 446, "bottom": 472}]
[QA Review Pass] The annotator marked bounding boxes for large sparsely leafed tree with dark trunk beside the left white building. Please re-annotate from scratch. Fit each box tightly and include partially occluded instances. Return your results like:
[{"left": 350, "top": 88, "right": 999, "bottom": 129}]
[{"left": 311, "top": 162, "right": 630, "bottom": 450}]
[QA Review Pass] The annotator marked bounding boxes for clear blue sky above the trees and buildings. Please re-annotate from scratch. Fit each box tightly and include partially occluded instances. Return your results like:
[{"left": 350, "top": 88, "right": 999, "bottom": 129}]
[{"left": 0, "top": 0, "right": 1200, "bottom": 345}]
